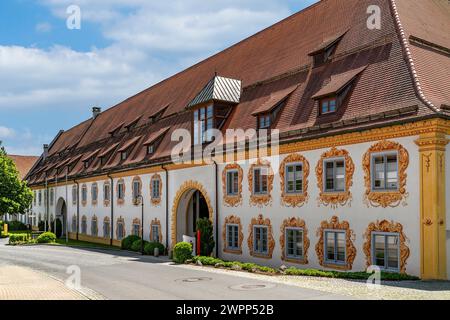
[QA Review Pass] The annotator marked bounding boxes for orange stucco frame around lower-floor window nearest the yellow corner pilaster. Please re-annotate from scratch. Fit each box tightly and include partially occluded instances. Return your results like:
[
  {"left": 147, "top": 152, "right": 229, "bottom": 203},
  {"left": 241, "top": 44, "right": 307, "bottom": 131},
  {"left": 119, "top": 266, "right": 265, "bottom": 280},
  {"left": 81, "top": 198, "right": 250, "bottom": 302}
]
[{"left": 363, "top": 220, "right": 410, "bottom": 273}]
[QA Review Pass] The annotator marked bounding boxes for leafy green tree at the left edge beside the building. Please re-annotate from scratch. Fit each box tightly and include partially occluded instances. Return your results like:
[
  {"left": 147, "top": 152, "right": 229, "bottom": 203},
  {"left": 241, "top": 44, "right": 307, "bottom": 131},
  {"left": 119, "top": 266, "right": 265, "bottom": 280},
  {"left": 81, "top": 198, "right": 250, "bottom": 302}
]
[{"left": 0, "top": 142, "right": 33, "bottom": 217}]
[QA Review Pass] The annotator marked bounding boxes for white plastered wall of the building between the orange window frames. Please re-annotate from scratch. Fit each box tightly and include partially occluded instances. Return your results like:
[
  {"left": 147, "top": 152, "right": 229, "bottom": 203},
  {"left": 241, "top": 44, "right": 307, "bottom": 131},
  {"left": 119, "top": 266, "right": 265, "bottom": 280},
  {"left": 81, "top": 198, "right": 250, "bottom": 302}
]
[{"left": 33, "top": 136, "right": 426, "bottom": 275}]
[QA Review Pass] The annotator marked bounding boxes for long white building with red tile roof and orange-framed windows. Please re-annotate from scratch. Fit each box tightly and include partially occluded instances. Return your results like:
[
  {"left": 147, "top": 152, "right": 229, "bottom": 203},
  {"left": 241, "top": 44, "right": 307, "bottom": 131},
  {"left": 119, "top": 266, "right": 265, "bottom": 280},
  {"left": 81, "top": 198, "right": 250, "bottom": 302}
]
[{"left": 27, "top": 0, "right": 450, "bottom": 279}]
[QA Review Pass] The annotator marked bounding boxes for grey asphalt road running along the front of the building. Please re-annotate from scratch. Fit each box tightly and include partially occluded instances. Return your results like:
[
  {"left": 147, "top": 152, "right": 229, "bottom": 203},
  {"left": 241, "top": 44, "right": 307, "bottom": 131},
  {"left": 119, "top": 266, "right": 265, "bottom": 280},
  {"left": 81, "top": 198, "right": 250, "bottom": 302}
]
[{"left": 0, "top": 239, "right": 348, "bottom": 300}]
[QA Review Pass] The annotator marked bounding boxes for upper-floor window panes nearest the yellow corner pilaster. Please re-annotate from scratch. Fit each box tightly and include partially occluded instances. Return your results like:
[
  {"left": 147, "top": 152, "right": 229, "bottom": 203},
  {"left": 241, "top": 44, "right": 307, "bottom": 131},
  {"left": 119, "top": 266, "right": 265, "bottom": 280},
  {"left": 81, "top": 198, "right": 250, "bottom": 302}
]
[{"left": 372, "top": 153, "right": 398, "bottom": 190}]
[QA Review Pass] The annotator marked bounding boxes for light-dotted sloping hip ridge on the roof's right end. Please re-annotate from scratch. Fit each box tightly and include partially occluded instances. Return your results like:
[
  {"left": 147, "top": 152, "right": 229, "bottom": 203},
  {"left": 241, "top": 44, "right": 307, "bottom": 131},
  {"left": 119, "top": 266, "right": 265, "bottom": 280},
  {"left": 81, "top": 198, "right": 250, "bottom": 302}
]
[{"left": 389, "top": 0, "right": 441, "bottom": 113}]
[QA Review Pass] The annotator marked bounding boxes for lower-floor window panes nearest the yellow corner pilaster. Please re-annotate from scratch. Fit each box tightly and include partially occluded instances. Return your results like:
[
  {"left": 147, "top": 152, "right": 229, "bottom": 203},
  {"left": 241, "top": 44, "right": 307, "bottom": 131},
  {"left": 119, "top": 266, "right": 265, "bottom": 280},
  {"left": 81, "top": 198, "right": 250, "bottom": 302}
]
[{"left": 372, "top": 233, "right": 400, "bottom": 271}]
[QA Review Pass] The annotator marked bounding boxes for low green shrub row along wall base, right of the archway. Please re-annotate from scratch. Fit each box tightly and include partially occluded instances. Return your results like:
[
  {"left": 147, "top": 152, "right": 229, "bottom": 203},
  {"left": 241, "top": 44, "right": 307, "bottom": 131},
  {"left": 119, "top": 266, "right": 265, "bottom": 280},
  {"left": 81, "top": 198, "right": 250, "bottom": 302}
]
[{"left": 192, "top": 256, "right": 419, "bottom": 281}]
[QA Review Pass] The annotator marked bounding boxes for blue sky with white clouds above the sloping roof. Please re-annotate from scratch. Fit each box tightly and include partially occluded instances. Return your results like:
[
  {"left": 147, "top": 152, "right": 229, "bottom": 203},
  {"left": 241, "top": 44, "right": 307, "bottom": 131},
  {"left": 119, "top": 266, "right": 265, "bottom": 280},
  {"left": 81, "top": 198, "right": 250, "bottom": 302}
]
[{"left": 0, "top": 0, "right": 316, "bottom": 155}]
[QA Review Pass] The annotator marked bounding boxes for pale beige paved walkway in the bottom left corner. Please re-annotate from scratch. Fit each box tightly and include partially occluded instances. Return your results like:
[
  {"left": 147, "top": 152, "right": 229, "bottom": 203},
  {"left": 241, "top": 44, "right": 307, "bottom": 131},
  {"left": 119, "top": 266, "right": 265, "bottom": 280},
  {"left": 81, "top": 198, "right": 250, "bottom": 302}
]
[{"left": 0, "top": 266, "right": 94, "bottom": 300}]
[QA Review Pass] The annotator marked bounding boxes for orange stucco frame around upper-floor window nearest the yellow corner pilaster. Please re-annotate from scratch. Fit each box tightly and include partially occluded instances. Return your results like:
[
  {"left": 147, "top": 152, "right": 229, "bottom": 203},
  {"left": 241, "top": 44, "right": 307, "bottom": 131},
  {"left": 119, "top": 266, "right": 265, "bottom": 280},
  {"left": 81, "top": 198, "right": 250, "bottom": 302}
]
[{"left": 362, "top": 140, "right": 409, "bottom": 208}]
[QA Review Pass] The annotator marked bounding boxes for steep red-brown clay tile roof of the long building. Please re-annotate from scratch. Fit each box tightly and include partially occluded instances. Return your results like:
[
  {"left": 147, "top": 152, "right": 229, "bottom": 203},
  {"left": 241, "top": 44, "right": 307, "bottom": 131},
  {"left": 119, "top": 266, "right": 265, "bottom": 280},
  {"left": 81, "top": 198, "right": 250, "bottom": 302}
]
[{"left": 26, "top": 0, "right": 450, "bottom": 183}]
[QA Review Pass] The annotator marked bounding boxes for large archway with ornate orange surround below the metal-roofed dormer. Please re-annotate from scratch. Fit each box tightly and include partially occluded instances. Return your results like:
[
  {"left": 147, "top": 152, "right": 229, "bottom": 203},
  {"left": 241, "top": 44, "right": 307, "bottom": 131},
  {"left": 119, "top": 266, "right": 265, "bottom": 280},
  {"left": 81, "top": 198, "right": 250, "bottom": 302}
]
[{"left": 171, "top": 180, "right": 214, "bottom": 248}]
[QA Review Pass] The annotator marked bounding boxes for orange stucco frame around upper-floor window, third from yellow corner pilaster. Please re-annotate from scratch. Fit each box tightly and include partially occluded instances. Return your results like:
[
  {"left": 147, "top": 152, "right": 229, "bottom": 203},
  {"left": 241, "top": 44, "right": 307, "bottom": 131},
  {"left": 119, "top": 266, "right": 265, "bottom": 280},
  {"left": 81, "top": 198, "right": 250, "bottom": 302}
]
[{"left": 279, "top": 153, "right": 309, "bottom": 207}]
